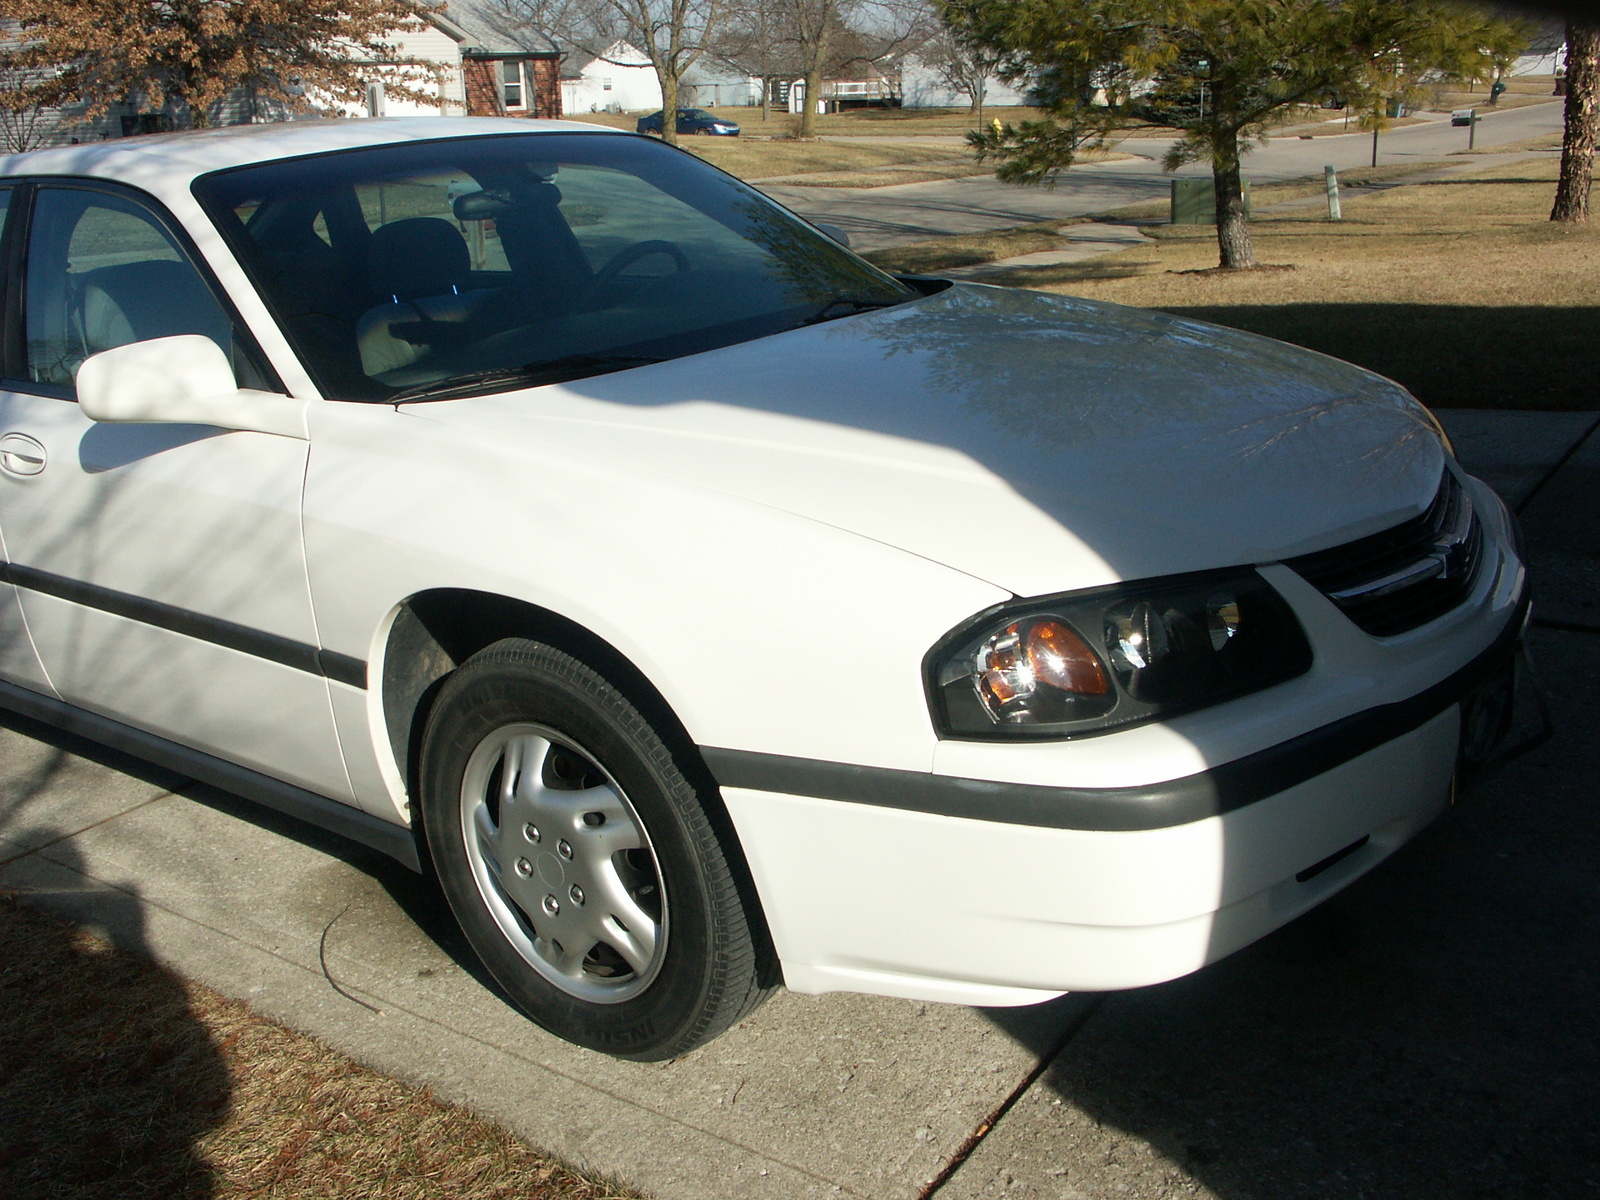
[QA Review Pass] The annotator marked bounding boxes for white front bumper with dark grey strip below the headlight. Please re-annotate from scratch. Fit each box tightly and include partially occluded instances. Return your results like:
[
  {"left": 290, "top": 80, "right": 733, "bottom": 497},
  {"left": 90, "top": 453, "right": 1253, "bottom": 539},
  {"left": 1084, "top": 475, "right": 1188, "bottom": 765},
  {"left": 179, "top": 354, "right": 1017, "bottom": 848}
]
[{"left": 706, "top": 597, "right": 1528, "bottom": 1005}]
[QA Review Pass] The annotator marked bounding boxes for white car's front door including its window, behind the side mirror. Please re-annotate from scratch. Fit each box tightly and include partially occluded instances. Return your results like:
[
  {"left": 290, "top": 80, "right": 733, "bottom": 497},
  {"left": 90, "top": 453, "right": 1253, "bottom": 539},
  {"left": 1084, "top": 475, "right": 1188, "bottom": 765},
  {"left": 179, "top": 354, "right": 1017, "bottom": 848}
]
[{"left": 0, "top": 181, "right": 350, "bottom": 800}]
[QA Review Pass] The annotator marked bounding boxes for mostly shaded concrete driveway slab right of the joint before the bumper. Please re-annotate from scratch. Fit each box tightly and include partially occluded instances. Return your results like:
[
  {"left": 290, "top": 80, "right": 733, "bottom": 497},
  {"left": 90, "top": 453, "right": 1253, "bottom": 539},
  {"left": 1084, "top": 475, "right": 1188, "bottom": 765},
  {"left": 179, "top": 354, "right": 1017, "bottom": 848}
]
[{"left": 985, "top": 634, "right": 1600, "bottom": 1200}]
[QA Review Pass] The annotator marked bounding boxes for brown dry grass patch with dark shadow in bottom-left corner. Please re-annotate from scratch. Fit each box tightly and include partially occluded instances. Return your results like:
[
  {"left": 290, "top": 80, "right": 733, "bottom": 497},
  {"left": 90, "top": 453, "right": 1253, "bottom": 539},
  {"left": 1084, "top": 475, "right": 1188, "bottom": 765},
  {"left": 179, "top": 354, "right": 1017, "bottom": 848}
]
[{"left": 0, "top": 893, "right": 637, "bottom": 1200}]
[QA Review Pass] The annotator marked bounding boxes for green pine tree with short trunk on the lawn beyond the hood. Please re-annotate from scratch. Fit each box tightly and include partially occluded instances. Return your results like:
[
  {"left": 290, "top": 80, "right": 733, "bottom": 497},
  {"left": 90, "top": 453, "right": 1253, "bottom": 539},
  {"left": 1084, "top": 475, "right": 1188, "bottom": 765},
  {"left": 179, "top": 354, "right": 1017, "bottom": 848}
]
[{"left": 941, "top": 0, "right": 1525, "bottom": 269}]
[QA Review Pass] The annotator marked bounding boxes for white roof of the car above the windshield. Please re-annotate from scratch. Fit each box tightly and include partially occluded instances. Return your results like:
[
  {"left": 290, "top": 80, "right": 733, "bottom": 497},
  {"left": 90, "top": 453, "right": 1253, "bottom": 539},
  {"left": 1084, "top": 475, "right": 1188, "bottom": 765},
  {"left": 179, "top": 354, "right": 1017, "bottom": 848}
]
[{"left": 0, "top": 117, "right": 627, "bottom": 192}]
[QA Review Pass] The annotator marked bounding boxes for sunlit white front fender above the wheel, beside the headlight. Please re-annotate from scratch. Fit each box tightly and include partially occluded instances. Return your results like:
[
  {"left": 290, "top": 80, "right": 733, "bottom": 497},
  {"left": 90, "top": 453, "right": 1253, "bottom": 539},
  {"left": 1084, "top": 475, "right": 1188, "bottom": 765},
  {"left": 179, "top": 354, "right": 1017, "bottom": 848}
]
[{"left": 306, "top": 397, "right": 1006, "bottom": 819}]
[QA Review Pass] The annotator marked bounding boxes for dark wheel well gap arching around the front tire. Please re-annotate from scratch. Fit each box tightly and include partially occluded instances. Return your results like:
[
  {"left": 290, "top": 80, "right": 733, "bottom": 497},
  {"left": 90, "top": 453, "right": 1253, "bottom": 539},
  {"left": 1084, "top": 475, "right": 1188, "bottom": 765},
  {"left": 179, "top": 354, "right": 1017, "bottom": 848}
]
[{"left": 381, "top": 587, "right": 779, "bottom": 982}]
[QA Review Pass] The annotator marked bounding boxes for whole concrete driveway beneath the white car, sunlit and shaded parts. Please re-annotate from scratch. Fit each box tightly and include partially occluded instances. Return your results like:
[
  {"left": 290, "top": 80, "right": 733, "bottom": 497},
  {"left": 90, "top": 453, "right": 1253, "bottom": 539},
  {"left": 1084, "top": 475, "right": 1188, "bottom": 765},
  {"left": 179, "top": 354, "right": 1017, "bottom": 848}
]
[{"left": 0, "top": 413, "right": 1600, "bottom": 1200}]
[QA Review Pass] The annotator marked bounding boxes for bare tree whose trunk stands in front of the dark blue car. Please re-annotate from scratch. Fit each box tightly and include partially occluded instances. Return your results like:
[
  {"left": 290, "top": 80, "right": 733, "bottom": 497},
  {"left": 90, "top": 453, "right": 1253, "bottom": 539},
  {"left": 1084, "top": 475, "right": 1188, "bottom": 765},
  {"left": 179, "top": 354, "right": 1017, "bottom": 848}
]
[{"left": 502, "top": 0, "right": 725, "bottom": 146}]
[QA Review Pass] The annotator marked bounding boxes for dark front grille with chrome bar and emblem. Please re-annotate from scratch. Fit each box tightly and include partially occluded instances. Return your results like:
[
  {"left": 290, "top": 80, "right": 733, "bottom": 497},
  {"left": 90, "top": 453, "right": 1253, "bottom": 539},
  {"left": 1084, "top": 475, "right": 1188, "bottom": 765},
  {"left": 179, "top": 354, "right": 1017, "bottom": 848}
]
[{"left": 1286, "top": 470, "right": 1483, "bottom": 637}]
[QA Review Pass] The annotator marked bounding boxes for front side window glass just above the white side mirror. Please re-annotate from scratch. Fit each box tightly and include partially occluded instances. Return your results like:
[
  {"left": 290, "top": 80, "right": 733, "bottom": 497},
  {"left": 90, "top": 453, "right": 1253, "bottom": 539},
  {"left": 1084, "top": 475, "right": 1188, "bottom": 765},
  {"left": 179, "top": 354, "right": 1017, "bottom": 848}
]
[{"left": 24, "top": 187, "right": 234, "bottom": 384}]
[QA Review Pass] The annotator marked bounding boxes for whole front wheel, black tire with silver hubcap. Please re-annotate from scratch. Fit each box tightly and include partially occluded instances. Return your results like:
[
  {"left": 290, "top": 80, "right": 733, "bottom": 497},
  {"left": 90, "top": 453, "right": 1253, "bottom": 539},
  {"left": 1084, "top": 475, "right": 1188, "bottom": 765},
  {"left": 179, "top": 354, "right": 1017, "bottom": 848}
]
[{"left": 421, "top": 638, "right": 768, "bottom": 1061}]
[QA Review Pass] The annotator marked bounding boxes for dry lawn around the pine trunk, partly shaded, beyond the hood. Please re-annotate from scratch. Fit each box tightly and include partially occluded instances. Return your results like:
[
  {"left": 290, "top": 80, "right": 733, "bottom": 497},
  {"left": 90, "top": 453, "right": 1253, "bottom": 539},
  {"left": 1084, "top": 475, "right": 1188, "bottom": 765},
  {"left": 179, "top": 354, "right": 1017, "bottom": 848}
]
[{"left": 979, "top": 158, "right": 1600, "bottom": 410}]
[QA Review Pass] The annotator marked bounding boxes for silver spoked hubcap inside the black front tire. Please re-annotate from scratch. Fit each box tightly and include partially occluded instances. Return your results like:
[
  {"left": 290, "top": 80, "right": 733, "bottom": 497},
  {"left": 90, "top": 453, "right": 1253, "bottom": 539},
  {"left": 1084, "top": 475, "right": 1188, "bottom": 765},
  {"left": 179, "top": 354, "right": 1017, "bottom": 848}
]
[{"left": 461, "top": 725, "right": 667, "bottom": 1005}]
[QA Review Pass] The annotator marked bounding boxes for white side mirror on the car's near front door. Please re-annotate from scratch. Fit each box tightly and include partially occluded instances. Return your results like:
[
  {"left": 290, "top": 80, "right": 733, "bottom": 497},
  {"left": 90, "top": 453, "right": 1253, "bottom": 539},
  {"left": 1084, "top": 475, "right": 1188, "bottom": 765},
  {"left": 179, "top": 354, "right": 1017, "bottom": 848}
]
[{"left": 77, "top": 333, "right": 309, "bottom": 442}]
